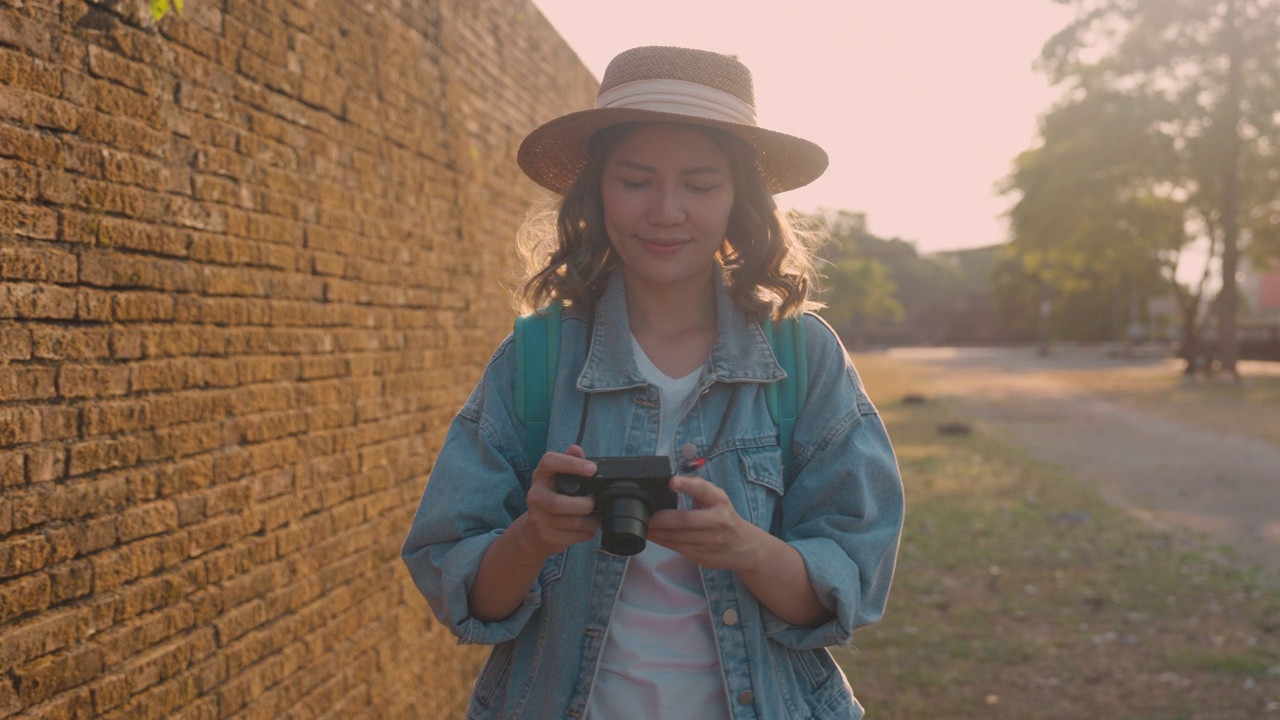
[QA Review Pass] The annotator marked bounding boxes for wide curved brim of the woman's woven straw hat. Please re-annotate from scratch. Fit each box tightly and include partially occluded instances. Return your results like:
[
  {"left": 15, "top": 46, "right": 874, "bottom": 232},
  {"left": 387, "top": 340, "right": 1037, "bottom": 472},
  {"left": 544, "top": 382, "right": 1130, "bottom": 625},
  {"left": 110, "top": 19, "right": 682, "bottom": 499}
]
[{"left": 516, "top": 108, "right": 828, "bottom": 195}]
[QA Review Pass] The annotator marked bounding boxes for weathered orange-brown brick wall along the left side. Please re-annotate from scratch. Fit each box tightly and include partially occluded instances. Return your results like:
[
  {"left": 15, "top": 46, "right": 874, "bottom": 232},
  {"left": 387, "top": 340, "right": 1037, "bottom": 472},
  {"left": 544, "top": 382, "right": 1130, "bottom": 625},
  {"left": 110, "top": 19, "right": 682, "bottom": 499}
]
[{"left": 0, "top": 0, "right": 595, "bottom": 720}]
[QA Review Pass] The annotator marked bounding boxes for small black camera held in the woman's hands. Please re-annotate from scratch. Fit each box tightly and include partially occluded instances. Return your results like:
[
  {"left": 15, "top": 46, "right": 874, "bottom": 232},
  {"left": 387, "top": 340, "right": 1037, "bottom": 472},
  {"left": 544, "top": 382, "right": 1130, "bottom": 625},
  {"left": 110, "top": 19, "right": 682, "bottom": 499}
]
[{"left": 556, "top": 456, "right": 676, "bottom": 555}]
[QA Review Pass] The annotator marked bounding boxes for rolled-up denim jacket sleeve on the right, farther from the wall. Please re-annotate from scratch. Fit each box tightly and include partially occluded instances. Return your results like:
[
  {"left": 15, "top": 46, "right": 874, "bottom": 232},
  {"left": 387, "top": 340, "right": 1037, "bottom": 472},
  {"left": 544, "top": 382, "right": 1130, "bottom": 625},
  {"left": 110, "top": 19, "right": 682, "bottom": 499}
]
[{"left": 765, "top": 316, "right": 905, "bottom": 650}]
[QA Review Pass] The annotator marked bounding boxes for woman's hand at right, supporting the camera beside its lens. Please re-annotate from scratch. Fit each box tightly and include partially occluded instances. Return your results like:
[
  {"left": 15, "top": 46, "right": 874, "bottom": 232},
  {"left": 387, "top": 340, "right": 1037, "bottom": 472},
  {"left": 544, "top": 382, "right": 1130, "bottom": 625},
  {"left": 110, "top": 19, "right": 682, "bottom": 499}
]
[{"left": 649, "top": 475, "right": 776, "bottom": 573}]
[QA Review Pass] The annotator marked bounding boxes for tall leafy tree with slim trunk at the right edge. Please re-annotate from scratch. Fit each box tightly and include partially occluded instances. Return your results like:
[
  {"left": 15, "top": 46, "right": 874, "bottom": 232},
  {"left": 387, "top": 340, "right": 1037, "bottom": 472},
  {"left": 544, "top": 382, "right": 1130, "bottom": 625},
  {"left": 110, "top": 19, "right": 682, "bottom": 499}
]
[{"left": 1010, "top": 0, "right": 1280, "bottom": 375}]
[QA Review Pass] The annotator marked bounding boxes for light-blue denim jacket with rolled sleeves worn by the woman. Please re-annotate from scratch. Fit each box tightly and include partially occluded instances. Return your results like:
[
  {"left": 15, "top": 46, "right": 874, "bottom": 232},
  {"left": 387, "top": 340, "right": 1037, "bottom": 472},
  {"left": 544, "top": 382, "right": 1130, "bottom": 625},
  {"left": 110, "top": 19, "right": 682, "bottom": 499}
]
[{"left": 402, "top": 273, "right": 904, "bottom": 720}]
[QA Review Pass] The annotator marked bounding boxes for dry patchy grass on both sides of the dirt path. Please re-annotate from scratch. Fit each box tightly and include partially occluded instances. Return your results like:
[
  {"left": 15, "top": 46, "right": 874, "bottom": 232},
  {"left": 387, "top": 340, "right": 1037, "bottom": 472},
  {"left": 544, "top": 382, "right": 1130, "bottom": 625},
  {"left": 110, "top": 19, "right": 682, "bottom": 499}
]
[{"left": 837, "top": 355, "right": 1280, "bottom": 720}]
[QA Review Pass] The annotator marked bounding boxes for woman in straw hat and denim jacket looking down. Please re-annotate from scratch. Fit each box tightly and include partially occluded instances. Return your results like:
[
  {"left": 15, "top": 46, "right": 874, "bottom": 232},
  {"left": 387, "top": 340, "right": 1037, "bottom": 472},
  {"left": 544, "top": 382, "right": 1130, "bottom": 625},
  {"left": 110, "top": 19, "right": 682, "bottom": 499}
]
[{"left": 403, "top": 47, "right": 902, "bottom": 720}]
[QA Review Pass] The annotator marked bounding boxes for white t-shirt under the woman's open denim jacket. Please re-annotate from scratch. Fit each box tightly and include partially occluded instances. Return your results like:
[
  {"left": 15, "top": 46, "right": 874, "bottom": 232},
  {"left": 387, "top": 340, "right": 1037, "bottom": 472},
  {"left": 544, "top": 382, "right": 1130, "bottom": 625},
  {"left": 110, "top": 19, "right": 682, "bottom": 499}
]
[{"left": 586, "top": 337, "right": 730, "bottom": 720}]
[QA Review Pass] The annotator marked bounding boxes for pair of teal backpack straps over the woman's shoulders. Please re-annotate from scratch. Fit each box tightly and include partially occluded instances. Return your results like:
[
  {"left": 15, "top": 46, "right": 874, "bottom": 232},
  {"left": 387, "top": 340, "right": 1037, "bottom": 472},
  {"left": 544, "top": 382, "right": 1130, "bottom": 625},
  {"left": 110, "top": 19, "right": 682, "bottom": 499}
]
[{"left": 513, "top": 304, "right": 809, "bottom": 477}]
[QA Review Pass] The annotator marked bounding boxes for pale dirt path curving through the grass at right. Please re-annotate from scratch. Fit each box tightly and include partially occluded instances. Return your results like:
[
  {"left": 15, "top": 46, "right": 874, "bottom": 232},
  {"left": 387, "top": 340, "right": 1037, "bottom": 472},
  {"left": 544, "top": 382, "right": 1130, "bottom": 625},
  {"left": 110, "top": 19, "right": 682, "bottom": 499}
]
[{"left": 891, "top": 348, "right": 1280, "bottom": 574}]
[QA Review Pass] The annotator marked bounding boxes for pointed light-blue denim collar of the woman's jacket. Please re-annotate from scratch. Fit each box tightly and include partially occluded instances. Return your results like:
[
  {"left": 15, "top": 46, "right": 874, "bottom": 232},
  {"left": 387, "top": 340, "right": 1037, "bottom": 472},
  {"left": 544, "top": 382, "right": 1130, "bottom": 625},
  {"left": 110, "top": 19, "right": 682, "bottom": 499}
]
[{"left": 577, "top": 270, "right": 786, "bottom": 392}]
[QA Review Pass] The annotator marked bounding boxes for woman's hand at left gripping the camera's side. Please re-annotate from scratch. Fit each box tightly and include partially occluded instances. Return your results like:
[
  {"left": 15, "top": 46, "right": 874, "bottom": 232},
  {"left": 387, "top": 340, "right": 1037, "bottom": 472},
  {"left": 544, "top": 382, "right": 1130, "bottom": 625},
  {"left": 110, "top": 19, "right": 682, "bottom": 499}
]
[{"left": 521, "top": 445, "right": 600, "bottom": 559}]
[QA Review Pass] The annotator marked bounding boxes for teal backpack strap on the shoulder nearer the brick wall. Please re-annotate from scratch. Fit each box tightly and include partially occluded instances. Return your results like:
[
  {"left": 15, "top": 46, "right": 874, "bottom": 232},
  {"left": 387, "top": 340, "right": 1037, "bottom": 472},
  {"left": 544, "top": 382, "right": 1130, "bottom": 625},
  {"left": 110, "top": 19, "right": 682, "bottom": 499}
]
[{"left": 515, "top": 302, "right": 561, "bottom": 466}]
